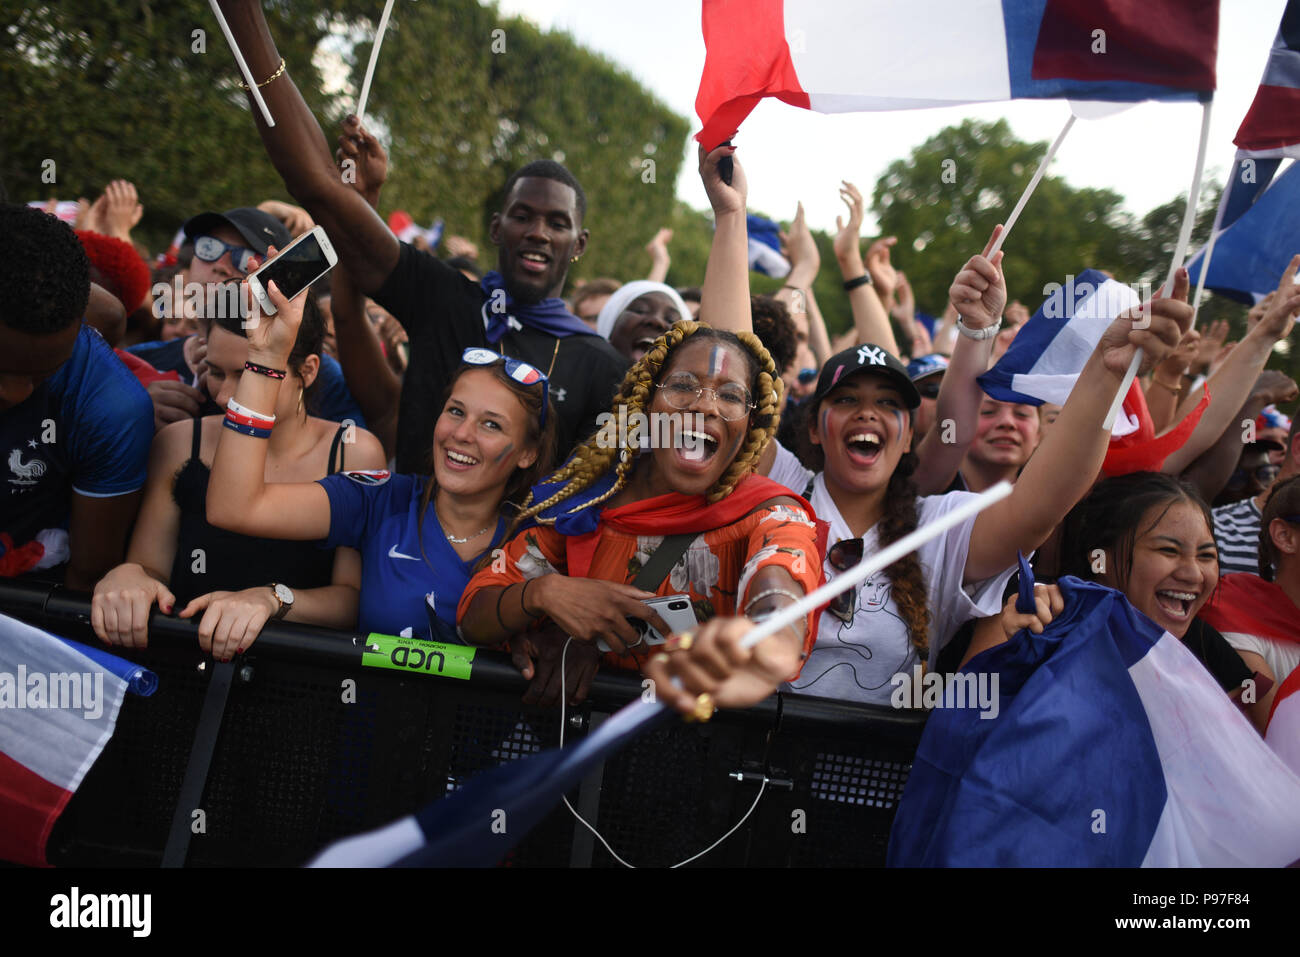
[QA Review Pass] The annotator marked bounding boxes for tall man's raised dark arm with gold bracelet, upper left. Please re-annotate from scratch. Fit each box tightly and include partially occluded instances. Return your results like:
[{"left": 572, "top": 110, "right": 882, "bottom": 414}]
[{"left": 220, "top": 0, "right": 399, "bottom": 295}]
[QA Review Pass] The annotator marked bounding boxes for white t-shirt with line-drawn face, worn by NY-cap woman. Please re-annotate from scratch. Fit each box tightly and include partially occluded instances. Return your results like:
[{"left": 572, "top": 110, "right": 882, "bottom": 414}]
[{"left": 783, "top": 475, "right": 1015, "bottom": 705}]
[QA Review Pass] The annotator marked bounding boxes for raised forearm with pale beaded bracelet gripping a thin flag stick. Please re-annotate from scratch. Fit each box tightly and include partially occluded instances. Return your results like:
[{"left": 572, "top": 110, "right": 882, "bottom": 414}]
[{"left": 917, "top": 225, "right": 1006, "bottom": 495}]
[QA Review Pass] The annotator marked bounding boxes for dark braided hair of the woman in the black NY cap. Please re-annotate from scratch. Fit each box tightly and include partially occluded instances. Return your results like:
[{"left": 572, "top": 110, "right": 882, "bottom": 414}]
[{"left": 798, "top": 399, "right": 930, "bottom": 667}]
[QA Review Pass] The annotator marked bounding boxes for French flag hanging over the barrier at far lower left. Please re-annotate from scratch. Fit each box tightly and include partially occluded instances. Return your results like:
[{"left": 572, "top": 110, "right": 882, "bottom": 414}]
[{"left": 0, "top": 615, "right": 157, "bottom": 867}]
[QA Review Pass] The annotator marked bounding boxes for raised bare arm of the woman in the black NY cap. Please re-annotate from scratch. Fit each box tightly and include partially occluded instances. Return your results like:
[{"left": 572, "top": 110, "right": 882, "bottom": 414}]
[{"left": 963, "top": 269, "right": 1192, "bottom": 583}]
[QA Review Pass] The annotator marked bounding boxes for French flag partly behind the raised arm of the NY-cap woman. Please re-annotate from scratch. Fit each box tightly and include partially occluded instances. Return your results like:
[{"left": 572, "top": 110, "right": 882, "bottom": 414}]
[{"left": 979, "top": 269, "right": 1209, "bottom": 475}]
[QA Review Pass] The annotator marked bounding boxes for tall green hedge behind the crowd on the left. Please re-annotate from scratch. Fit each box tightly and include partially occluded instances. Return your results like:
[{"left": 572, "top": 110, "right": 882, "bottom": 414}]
[{"left": 0, "top": 0, "right": 703, "bottom": 278}]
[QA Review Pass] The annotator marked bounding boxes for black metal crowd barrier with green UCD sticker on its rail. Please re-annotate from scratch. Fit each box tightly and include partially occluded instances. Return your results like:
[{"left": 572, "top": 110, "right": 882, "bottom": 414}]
[{"left": 0, "top": 581, "right": 924, "bottom": 866}]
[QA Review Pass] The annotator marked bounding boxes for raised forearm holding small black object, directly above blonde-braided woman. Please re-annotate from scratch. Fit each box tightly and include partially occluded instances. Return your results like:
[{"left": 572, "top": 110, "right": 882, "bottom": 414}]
[{"left": 699, "top": 146, "right": 754, "bottom": 333}]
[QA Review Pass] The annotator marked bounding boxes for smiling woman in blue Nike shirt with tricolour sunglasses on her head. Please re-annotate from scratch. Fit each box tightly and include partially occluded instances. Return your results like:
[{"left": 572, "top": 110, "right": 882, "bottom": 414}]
[{"left": 208, "top": 280, "right": 555, "bottom": 642}]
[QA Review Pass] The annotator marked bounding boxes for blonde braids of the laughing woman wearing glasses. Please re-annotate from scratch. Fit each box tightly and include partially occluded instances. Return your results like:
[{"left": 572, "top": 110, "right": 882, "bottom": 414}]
[{"left": 511, "top": 320, "right": 783, "bottom": 532}]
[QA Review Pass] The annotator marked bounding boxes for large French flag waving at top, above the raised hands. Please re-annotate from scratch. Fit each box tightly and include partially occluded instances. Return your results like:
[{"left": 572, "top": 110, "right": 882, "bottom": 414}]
[{"left": 696, "top": 0, "right": 1218, "bottom": 148}]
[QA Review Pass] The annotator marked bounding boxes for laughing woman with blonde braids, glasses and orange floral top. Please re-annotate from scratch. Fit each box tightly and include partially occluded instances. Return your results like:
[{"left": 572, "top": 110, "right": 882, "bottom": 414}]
[{"left": 460, "top": 314, "right": 822, "bottom": 714}]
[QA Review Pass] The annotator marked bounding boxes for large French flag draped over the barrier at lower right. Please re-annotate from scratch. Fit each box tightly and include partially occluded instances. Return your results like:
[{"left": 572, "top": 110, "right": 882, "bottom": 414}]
[{"left": 888, "top": 577, "right": 1300, "bottom": 867}]
